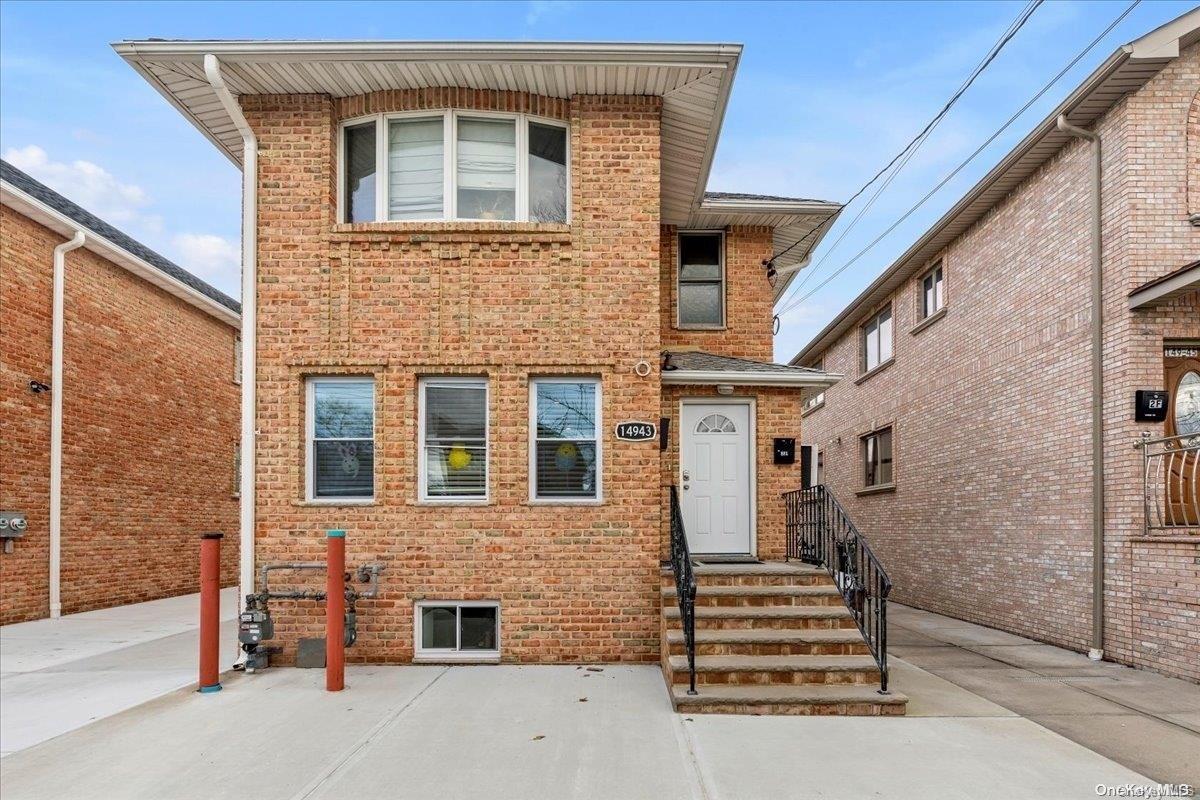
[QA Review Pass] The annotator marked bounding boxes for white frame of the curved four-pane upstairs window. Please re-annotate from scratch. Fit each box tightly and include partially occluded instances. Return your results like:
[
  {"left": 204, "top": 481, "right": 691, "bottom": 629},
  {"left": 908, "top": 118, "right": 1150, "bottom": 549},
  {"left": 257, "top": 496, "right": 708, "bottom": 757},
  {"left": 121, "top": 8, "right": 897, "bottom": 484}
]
[{"left": 336, "top": 108, "right": 566, "bottom": 224}]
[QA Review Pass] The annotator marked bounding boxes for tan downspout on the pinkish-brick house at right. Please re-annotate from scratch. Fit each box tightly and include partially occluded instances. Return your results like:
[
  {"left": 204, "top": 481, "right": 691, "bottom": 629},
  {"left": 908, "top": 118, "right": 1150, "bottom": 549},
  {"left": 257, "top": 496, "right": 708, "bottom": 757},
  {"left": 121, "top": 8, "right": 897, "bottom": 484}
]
[{"left": 1058, "top": 114, "right": 1104, "bottom": 661}]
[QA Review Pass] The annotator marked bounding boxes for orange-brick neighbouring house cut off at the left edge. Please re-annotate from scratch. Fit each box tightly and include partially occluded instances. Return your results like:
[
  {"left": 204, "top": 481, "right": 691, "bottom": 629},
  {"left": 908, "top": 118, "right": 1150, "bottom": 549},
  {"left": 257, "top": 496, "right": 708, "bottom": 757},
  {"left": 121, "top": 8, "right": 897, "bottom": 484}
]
[{"left": 0, "top": 162, "right": 240, "bottom": 624}]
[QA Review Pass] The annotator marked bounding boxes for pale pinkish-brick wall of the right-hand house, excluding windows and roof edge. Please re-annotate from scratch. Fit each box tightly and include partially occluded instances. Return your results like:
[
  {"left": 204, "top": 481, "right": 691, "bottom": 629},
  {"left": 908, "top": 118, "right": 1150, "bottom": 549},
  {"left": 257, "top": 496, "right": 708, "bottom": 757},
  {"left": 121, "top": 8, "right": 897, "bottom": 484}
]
[{"left": 804, "top": 47, "right": 1200, "bottom": 679}]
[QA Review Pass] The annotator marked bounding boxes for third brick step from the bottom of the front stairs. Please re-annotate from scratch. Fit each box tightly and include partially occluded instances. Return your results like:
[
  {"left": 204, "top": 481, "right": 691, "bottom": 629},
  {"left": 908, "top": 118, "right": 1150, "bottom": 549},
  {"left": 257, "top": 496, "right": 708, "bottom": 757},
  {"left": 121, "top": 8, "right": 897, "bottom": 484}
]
[{"left": 666, "top": 627, "right": 871, "bottom": 656}]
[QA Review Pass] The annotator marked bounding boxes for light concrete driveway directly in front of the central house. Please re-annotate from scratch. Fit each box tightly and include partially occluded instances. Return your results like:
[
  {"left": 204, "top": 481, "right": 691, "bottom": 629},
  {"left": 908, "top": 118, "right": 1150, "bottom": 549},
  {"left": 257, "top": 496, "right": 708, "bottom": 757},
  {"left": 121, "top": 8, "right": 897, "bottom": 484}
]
[{"left": 0, "top": 663, "right": 1150, "bottom": 800}]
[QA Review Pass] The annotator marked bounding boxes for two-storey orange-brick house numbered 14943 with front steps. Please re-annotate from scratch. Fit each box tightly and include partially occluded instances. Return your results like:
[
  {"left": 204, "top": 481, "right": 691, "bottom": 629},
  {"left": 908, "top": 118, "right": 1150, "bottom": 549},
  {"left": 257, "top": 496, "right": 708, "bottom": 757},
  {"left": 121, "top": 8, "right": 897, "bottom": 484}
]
[{"left": 114, "top": 41, "right": 904, "bottom": 714}]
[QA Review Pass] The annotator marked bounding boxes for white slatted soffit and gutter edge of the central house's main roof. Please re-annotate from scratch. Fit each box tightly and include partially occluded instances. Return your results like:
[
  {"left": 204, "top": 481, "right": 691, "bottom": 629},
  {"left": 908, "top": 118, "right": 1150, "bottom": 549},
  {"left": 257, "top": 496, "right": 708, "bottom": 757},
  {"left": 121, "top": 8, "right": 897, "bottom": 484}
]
[{"left": 113, "top": 40, "right": 742, "bottom": 224}]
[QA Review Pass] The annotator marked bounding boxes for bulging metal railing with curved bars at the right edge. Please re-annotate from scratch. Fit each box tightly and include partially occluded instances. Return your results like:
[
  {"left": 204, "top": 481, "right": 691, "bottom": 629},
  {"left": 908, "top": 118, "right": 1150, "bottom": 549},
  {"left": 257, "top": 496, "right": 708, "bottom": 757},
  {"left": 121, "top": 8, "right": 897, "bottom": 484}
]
[{"left": 1139, "top": 434, "right": 1200, "bottom": 534}]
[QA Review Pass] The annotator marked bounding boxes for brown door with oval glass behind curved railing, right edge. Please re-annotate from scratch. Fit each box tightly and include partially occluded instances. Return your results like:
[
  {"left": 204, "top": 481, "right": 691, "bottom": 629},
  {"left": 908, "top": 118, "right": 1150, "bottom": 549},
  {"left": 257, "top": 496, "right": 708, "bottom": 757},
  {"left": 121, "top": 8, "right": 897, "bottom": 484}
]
[{"left": 1163, "top": 342, "right": 1200, "bottom": 527}]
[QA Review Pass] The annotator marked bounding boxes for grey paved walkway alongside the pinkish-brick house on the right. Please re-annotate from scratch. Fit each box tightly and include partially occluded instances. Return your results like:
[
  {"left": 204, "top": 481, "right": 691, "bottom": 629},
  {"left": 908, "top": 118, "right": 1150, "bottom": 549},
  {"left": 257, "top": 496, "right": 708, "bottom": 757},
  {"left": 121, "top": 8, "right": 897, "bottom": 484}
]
[{"left": 888, "top": 603, "right": 1200, "bottom": 787}]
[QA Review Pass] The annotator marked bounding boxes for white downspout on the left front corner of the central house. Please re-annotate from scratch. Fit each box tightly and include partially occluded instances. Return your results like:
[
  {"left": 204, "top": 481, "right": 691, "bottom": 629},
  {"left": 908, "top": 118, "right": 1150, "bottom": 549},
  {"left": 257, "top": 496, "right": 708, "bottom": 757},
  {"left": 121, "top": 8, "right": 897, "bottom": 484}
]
[{"left": 204, "top": 53, "right": 258, "bottom": 642}]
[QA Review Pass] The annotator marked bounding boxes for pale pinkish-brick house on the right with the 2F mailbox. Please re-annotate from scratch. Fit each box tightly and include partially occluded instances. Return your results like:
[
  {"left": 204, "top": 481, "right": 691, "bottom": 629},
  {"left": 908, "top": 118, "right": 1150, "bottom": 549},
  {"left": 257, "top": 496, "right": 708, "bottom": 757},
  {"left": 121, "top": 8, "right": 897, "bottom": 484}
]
[{"left": 792, "top": 11, "right": 1200, "bottom": 680}]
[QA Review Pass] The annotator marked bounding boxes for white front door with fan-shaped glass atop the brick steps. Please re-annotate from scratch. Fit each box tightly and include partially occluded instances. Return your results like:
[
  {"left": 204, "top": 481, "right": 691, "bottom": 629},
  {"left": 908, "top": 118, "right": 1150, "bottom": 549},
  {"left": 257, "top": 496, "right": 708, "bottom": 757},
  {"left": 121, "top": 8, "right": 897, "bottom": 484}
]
[{"left": 679, "top": 402, "right": 752, "bottom": 555}]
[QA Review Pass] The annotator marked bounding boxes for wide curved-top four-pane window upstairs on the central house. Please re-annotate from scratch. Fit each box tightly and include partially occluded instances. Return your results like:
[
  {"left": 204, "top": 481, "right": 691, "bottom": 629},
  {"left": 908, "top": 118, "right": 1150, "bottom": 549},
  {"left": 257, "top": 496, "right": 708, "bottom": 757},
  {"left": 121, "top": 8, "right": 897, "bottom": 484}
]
[{"left": 338, "top": 110, "right": 570, "bottom": 223}]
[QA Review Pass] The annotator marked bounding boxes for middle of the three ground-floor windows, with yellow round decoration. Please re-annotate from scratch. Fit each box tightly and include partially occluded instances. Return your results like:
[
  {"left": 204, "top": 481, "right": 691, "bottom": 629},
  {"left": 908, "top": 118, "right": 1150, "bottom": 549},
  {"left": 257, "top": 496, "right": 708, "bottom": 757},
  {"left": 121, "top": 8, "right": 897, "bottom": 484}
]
[{"left": 420, "top": 378, "right": 487, "bottom": 500}]
